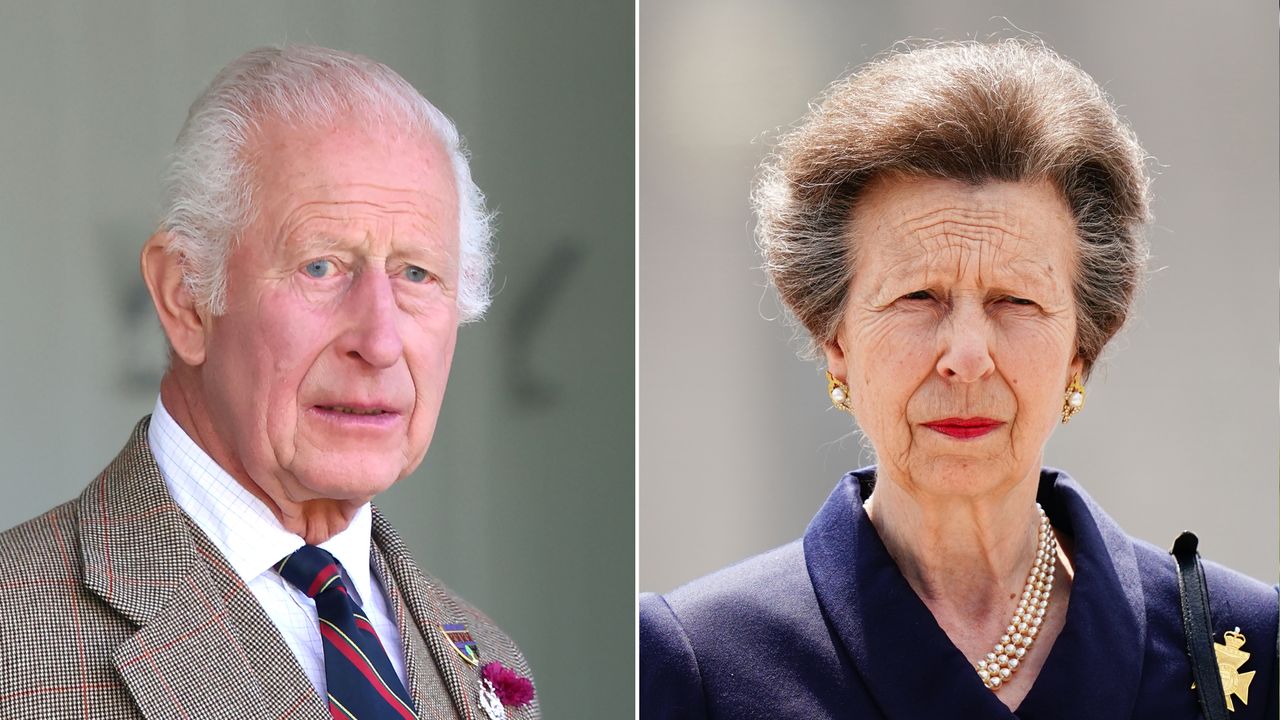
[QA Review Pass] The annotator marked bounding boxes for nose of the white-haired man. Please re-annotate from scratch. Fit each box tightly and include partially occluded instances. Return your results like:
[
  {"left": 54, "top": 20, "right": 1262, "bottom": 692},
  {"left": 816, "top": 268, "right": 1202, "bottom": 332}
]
[{"left": 339, "top": 270, "right": 404, "bottom": 368}]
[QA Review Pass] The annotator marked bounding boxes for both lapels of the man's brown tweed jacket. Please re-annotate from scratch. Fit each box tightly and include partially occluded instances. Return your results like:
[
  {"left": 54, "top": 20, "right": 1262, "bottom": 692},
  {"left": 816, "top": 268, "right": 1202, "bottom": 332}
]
[{"left": 78, "top": 418, "right": 479, "bottom": 720}]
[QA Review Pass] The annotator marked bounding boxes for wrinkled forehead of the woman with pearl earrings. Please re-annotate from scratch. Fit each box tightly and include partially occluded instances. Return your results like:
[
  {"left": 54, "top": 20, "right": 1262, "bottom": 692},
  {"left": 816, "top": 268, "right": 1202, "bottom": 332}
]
[{"left": 850, "top": 178, "right": 1076, "bottom": 282}]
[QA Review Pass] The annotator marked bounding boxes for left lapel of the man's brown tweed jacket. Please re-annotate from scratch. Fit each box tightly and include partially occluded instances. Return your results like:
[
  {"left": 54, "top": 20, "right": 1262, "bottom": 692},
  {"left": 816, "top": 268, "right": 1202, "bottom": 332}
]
[{"left": 79, "top": 418, "right": 326, "bottom": 720}]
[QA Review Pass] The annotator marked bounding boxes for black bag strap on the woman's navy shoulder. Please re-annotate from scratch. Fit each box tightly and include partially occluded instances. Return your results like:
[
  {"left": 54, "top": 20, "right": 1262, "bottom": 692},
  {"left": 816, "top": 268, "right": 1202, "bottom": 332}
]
[{"left": 1170, "top": 532, "right": 1228, "bottom": 720}]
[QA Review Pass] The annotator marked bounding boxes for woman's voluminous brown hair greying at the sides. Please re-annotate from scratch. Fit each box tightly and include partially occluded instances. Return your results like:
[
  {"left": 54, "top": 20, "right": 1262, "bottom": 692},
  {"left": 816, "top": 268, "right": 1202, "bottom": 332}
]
[{"left": 753, "top": 40, "right": 1149, "bottom": 377}]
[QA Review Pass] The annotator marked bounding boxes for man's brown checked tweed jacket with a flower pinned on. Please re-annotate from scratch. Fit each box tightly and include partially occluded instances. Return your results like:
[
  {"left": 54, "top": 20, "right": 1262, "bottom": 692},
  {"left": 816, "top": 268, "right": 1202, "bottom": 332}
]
[{"left": 0, "top": 418, "right": 539, "bottom": 720}]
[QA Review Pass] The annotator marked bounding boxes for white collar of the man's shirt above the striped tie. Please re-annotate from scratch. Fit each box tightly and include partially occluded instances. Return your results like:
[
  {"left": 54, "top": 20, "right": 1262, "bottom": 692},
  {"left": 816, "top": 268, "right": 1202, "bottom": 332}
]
[{"left": 147, "top": 397, "right": 372, "bottom": 602}]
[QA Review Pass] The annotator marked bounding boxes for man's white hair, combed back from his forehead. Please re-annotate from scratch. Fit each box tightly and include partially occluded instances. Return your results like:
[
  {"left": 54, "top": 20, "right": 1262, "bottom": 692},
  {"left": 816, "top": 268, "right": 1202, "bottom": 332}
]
[{"left": 160, "top": 45, "right": 493, "bottom": 323}]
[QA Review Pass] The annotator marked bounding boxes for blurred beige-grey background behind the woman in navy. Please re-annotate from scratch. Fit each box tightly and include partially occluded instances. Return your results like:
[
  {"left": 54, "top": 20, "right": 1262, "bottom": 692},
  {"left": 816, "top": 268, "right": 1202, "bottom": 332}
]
[{"left": 639, "top": 0, "right": 1280, "bottom": 591}]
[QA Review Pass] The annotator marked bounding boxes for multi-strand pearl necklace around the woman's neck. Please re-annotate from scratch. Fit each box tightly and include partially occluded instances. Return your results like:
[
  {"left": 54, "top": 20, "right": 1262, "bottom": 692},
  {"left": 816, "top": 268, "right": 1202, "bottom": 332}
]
[{"left": 974, "top": 502, "right": 1057, "bottom": 691}]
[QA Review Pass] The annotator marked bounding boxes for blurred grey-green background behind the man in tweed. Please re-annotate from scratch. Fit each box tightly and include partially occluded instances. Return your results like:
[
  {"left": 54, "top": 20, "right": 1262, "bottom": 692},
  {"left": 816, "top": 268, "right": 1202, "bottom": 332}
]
[{"left": 0, "top": 0, "right": 635, "bottom": 717}]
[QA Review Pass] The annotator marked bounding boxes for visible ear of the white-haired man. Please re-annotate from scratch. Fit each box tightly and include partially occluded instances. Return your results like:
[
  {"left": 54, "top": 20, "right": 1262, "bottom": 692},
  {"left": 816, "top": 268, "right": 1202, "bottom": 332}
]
[{"left": 142, "top": 231, "right": 209, "bottom": 366}]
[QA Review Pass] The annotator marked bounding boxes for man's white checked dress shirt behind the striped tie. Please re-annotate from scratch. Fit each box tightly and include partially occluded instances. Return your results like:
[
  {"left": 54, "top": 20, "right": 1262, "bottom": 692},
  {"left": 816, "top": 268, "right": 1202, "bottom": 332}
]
[{"left": 147, "top": 398, "right": 408, "bottom": 697}]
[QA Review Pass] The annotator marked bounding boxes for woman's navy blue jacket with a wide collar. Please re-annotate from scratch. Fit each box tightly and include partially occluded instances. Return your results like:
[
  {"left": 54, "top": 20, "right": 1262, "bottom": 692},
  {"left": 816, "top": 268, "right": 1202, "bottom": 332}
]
[{"left": 640, "top": 468, "right": 1277, "bottom": 720}]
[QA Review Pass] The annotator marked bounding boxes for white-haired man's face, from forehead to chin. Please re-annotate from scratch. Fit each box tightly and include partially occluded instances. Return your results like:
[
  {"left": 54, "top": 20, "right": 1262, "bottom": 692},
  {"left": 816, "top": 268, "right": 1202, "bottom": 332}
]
[{"left": 201, "top": 117, "right": 458, "bottom": 502}]
